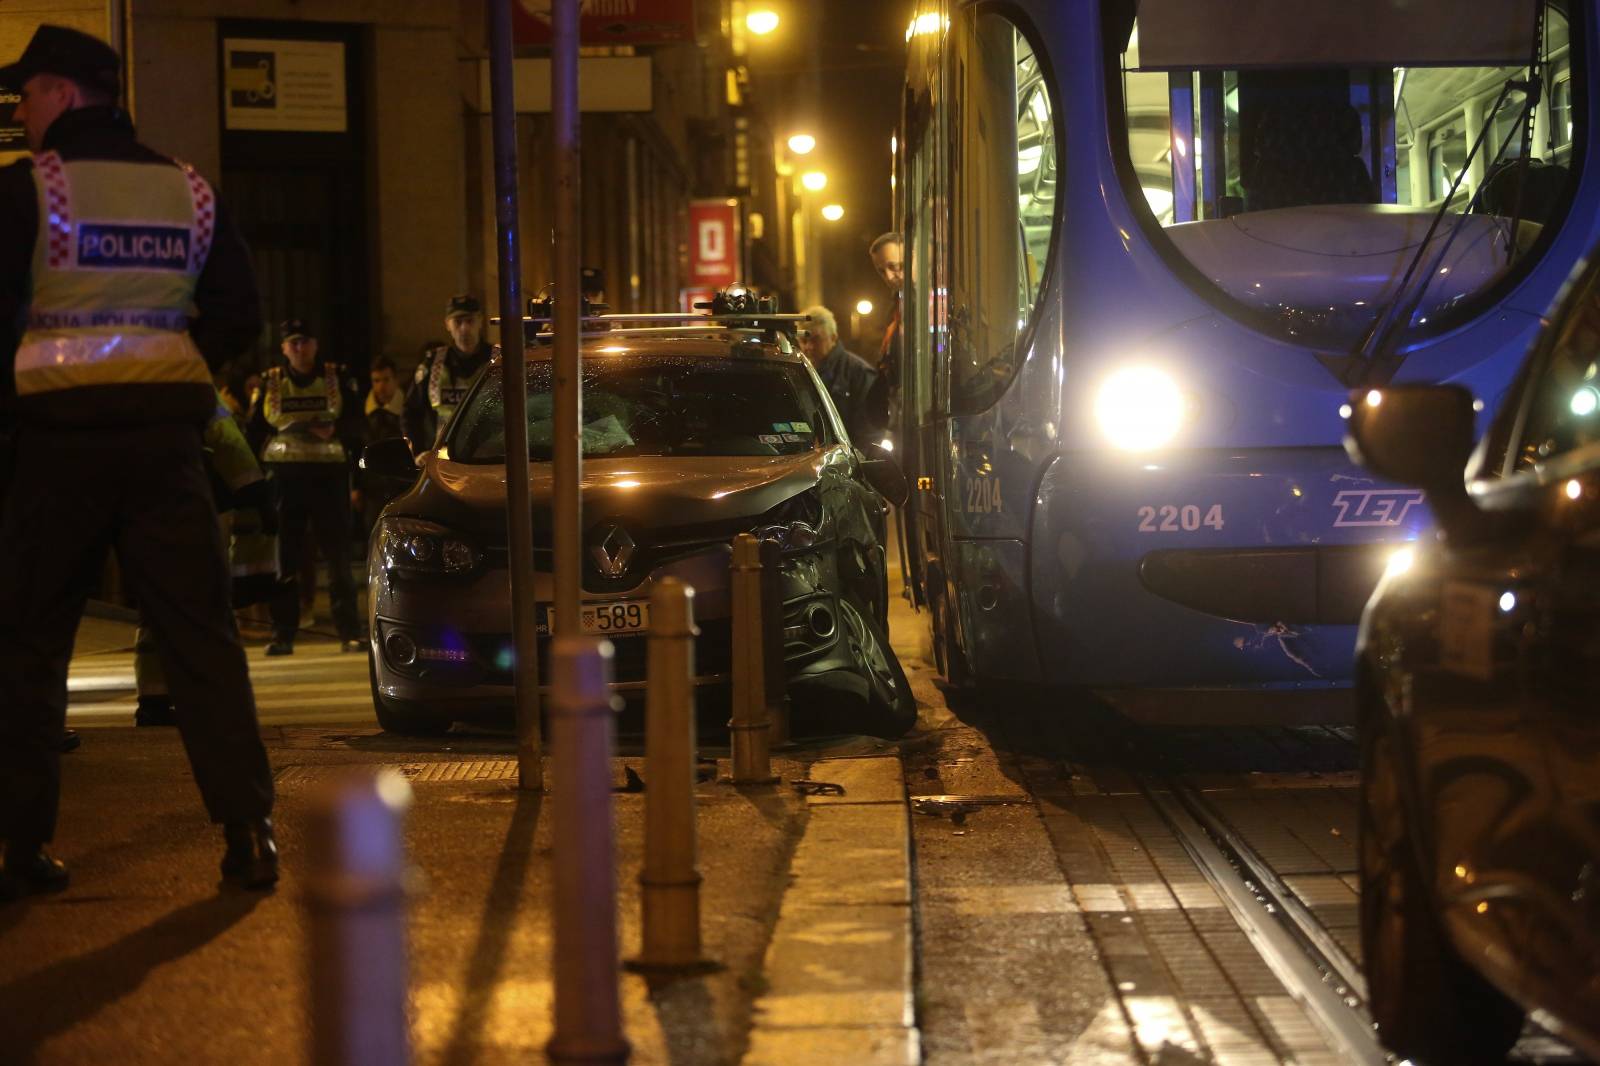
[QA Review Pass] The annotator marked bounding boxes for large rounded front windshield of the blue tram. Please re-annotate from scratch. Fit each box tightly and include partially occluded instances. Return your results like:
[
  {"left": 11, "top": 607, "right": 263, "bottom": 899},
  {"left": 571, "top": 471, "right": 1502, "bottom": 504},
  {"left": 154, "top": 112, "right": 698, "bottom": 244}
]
[{"left": 1106, "top": 0, "right": 1582, "bottom": 349}]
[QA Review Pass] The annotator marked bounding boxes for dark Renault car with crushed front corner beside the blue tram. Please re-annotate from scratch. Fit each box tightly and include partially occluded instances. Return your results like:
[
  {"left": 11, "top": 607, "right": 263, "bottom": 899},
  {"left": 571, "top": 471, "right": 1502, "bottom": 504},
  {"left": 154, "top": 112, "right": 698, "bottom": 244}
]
[{"left": 365, "top": 312, "right": 915, "bottom": 735}]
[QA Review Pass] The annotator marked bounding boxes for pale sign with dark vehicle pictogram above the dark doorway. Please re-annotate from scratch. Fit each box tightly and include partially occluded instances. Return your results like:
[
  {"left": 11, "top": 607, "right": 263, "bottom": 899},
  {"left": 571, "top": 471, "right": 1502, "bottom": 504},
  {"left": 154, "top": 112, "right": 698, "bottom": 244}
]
[{"left": 222, "top": 37, "right": 347, "bottom": 133}]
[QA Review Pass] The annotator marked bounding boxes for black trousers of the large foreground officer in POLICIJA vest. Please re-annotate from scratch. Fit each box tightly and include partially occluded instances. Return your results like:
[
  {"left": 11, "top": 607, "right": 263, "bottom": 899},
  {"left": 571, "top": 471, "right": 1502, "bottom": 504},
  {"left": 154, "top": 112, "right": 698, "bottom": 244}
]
[{"left": 0, "top": 426, "right": 272, "bottom": 845}]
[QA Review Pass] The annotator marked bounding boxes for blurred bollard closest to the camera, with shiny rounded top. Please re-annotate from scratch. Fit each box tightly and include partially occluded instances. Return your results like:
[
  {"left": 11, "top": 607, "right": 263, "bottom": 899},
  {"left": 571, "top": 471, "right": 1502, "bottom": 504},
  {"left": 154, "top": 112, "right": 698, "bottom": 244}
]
[{"left": 306, "top": 770, "right": 411, "bottom": 1066}]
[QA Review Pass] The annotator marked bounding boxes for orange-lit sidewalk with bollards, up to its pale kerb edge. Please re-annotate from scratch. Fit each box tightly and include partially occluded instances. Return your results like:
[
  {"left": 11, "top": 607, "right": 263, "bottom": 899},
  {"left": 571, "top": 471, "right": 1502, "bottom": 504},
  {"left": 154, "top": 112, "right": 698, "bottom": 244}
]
[{"left": 0, "top": 681, "right": 917, "bottom": 1064}]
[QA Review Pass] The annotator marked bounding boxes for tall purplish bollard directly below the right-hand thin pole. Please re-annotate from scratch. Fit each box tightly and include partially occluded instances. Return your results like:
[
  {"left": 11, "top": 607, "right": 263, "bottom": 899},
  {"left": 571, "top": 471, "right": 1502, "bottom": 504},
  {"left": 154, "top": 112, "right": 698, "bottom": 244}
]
[{"left": 544, "top": 637, "right": 629, "bottom": 1063}]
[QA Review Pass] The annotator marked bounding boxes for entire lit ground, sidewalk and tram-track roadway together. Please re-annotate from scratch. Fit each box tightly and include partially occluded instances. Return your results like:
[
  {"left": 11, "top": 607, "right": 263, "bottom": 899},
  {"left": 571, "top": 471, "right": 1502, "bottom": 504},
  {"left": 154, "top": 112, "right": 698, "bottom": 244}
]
[{"left": 12, "top": 582, "right": 1581, "bottom": 1066}]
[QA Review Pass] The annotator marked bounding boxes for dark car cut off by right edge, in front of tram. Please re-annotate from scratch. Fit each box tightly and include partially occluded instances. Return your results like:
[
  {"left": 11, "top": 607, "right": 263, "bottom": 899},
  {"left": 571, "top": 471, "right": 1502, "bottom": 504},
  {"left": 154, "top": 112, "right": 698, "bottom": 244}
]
[{"left": 1346, "top": 252, "right": 1600, "bottom": 1064}]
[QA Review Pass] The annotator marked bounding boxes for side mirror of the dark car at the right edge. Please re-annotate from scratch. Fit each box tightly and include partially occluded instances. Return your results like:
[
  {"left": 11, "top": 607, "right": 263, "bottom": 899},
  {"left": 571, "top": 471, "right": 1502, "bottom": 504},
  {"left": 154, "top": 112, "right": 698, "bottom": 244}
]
[{"left": 1344, "top": 386, "right": 1483, "bottom": 539}]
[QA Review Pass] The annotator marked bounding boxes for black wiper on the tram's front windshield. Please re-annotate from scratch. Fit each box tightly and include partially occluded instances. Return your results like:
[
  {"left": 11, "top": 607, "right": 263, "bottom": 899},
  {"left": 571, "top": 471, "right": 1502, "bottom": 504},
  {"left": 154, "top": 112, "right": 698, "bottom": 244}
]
[{"left": 1350, "top": 3, "right": 1544, "bottom": 389}]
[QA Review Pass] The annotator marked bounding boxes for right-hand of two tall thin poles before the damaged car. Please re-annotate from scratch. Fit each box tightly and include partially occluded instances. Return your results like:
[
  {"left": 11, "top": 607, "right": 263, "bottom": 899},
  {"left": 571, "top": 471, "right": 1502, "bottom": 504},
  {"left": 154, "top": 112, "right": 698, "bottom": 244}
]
[{"left": 550, "top": 0, "right": 584, "bottom": 637}]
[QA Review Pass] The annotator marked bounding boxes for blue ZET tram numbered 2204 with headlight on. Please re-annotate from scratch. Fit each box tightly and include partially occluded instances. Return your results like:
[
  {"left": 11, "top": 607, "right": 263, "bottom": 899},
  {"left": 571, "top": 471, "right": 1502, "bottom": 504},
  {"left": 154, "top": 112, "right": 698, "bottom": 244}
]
[{"left": 896, "top": 0, "right": 1600, "bottom": 707}]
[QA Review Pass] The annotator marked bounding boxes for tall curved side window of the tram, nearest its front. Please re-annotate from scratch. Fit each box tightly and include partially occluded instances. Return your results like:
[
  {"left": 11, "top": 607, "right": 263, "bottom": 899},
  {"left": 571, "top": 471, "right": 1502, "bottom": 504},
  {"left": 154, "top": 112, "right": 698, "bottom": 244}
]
[{"left": 949, "top": 8, "right": 1058, "bottom": 413}]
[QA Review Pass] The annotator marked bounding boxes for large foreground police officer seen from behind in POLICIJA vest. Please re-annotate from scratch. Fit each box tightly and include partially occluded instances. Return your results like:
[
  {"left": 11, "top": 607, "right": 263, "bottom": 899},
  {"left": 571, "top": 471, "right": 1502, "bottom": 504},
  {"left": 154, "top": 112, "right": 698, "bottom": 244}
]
[{"left": 0, "top": 26, "right": 277, "bottom": 893}]
